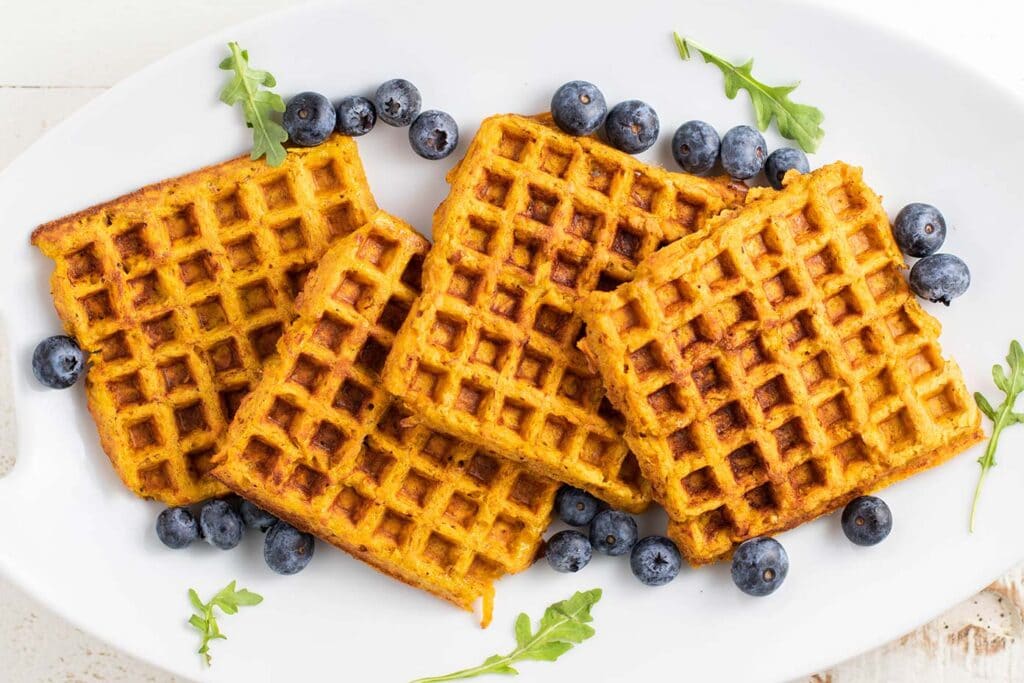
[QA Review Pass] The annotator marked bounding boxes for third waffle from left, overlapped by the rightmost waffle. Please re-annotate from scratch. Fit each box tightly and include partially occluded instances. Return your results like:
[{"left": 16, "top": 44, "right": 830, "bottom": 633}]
[{"left": 384, "top": 115, "right": 742, "bottom": 511}]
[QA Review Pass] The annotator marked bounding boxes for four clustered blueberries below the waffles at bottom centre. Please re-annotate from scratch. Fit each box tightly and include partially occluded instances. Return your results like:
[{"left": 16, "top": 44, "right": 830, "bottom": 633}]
[{"left": 547, "top": 486, "right": 683, "bottom": 586}]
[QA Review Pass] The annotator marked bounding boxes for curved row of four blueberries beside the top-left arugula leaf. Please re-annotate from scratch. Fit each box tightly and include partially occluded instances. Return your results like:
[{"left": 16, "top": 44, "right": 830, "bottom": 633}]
[{"left": 284, "top": 78, "right": 459, "bottom": 160}]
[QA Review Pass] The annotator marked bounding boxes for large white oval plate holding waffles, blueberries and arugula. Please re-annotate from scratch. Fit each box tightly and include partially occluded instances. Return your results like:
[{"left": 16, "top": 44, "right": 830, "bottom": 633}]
[{"left": 0, "top": 0, "right": 1024, "bottom": 681}]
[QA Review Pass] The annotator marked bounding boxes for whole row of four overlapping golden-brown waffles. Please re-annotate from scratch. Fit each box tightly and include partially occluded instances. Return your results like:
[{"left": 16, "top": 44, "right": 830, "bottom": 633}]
[{"left": 33, "top": 115, "right": 980, "bottom": 622}]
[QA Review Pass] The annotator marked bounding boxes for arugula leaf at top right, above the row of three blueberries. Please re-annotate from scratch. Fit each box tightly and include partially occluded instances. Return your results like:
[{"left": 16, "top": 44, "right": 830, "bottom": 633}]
[{"left": 673, "top": 33, "right": 825, "bottom": 152}]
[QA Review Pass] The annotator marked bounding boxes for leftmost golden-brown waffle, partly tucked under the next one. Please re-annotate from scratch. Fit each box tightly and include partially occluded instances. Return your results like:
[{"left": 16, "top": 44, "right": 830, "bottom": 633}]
[{"left": 32, "top": 136, "right": 376, "bottom": 505}]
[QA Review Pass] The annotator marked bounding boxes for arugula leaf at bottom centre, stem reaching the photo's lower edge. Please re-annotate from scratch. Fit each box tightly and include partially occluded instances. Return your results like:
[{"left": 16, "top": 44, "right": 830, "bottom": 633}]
[{"left": 412, "top": 588, "right": 601, "bottom": 683}]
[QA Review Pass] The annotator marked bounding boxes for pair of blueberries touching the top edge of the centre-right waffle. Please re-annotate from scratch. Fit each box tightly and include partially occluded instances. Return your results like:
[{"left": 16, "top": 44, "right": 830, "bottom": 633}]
[{"left": 551, "top": 81, "right": 662, "bottom": 155}]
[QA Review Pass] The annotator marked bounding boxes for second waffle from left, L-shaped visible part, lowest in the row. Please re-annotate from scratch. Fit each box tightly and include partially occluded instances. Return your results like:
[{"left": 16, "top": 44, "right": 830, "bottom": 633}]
[{"left": 213, "top": 213, "right": 557, "bottom": 622}]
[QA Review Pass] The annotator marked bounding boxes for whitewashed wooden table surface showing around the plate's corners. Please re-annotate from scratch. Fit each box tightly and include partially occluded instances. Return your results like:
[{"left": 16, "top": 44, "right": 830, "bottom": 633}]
[{"left": 0, "top": 0, "right": 1024, "bottom": 683}]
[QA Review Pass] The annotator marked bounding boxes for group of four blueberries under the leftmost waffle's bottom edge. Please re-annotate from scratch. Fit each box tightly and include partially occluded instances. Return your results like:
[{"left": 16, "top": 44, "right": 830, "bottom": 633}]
[{"left": 157, "top": 499, "right": 315, "bottom": 574}]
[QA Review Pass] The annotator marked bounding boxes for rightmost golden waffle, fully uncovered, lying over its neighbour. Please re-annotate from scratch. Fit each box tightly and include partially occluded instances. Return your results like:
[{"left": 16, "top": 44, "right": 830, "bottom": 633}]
[{"left": 583, "top": 164, "right": 982, "bottom": 564}]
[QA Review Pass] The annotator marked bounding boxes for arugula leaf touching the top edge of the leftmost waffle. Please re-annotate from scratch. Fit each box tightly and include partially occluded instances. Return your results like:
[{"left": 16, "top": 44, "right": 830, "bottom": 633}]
[{"left": 220, "top": 42, "right": 288, "bottom": 166}]
